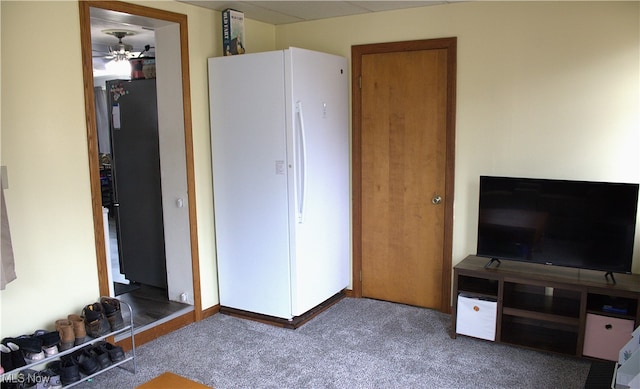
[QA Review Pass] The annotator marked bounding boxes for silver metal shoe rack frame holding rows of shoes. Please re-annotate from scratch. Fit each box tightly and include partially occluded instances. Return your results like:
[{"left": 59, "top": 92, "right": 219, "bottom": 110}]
[{"left": 0, "top": 296, "right": 136, "bottom": 388}]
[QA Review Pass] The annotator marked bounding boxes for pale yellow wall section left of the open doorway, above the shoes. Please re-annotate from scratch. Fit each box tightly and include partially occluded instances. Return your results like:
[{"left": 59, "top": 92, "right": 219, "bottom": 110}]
[{"left": 0, "top": 1, "right": 98, "bottom": 337}]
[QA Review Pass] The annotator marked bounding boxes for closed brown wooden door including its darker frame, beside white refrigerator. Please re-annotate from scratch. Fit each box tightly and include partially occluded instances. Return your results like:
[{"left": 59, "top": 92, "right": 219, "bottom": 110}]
[{"left": 352, "top": 38, "right": 455, "bottom": 312}]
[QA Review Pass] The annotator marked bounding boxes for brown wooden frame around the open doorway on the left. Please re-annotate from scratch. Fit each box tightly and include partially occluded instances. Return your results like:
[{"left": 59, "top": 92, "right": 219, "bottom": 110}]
[{"left": 78, "top": 1, "right": 203, "bottom": 318}]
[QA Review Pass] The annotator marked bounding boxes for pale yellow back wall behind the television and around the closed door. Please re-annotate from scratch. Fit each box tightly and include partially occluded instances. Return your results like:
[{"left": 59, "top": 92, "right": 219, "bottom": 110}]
[{"left": 276, "top": 2, "right": 640, "bottom": 273}]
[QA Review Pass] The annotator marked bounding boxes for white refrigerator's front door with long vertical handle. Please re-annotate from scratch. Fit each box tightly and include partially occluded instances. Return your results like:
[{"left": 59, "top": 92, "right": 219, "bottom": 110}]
[{"left": 285, "top": 48, "right": 350, "bottom": 316}]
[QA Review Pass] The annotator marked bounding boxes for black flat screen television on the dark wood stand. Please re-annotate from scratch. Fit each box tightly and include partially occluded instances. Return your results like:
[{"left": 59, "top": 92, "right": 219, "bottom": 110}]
[{"left": 477, "top": 176, "right": 638, "bottom": 274}]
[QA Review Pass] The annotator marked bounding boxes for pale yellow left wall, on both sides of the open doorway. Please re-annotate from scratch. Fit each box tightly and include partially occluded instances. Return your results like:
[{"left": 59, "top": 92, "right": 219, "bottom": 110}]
[{"left": 0, "top": 0, "right": 275, "bottom": 338}]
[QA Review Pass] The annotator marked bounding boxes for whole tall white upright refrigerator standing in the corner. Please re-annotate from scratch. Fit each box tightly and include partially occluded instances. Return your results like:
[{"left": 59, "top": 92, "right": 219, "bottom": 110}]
[{"left": 209, "top": 48, "right": 350, "bottom": 319}]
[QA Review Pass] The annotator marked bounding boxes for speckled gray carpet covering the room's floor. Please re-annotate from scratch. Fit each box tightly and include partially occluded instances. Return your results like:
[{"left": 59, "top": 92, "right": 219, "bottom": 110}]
[{"left": 78, "top": 298, "right": 590, "bottom": 389}]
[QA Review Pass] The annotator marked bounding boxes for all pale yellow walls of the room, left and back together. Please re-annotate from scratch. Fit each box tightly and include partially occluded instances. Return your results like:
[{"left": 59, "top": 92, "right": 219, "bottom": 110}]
[{"left": 0, "top": 1, "right": 640, "bottom": 338}]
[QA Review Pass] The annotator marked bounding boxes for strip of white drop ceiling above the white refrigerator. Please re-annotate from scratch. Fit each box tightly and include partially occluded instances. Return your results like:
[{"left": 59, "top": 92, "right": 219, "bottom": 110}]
[{"left": 179, "top": 0, "right": 461, "bottom": 25}]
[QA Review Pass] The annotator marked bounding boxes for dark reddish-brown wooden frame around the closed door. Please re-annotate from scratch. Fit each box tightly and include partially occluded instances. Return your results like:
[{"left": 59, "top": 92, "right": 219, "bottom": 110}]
[{"left": 351, "top": 37, "right": 457, "bottom": 313}]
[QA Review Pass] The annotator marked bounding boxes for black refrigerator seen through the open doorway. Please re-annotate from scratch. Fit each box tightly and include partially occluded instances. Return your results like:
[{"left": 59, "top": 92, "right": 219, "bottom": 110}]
[{"left": 106, "top": 79, "right": 167, "bottom": 289}]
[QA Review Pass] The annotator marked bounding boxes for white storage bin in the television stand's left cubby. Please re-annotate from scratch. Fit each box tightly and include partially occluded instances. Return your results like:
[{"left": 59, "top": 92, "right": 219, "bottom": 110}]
[{"left": 456, "top": 294, "right": 498, "bottom": 341}]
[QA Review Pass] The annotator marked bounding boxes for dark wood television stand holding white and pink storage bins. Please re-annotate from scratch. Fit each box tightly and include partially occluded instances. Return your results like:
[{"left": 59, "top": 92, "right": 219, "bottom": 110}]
[{"left": 451, "top": 255, "right": 640, "bottom": 361}]
